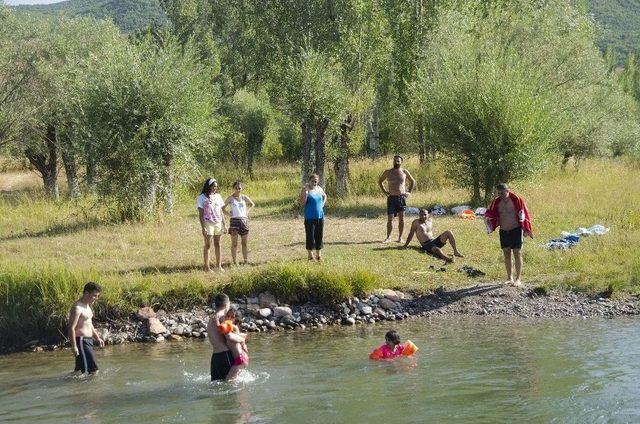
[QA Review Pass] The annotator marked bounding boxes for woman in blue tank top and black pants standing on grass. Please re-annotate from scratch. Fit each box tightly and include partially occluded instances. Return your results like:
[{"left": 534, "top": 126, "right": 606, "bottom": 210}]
[{"left": 298, "top": 174, "right": 327, "bottom": 261}]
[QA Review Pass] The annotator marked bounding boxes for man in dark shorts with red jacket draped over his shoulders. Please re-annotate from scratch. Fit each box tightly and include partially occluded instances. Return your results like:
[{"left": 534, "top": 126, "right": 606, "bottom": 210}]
[{"left": 485, "top": 183, "right": 533, "bottom": 286}]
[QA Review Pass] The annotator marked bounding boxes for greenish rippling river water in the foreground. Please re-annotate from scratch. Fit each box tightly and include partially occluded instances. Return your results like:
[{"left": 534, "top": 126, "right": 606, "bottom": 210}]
[{"left": 0, "top": 317, "right": 640, "bottom": 424}]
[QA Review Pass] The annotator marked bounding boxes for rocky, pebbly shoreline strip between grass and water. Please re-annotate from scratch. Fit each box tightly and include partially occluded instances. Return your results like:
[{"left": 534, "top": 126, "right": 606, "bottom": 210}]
[{"left": 6, "top": 284, "right": 640, "bottom": 354}]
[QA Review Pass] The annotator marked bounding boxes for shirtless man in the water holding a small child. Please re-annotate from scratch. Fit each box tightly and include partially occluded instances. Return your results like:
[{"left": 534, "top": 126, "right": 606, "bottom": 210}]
[{"left": 207, "top": 293, "right": 250, "bottom": 381}]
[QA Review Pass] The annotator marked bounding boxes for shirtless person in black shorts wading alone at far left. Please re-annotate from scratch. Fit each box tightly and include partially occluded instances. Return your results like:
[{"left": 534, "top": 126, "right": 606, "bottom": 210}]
[{"left": 69, "top": 283, "right": 104, "bottom": 374}]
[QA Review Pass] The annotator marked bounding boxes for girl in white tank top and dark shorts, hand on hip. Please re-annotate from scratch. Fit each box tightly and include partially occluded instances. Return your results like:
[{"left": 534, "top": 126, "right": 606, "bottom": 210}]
[{"left": 222, "top": 181, "right": 255, "bottom": 265}]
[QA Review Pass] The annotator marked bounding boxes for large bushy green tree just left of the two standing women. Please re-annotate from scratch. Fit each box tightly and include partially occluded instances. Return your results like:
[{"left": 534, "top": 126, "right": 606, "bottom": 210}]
[{"left": 79, "top": 33, "right": 217, "bottom": 219}]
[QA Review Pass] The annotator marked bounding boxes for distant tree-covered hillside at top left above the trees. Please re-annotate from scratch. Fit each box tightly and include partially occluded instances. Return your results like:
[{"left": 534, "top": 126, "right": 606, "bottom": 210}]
[{"left": 16, "top": 0, "right": 167, "bottom": 33}]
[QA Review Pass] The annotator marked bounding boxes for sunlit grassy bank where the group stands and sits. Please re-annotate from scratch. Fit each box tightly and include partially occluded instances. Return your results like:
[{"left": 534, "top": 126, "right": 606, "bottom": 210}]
[{"left": 0, "top": 159, "right": 640, "bottom": 346}]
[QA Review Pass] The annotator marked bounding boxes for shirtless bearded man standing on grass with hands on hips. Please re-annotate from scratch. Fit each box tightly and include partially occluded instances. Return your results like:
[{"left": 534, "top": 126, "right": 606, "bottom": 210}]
[{"left": 378, "top": 155, "right": 416, "bottom": 243}]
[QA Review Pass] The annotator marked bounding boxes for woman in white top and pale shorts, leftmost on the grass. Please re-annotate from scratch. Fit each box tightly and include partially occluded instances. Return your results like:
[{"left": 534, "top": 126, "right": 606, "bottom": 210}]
[{"left": 196, "top": 178, "right": 226, "bottom": 272}]
